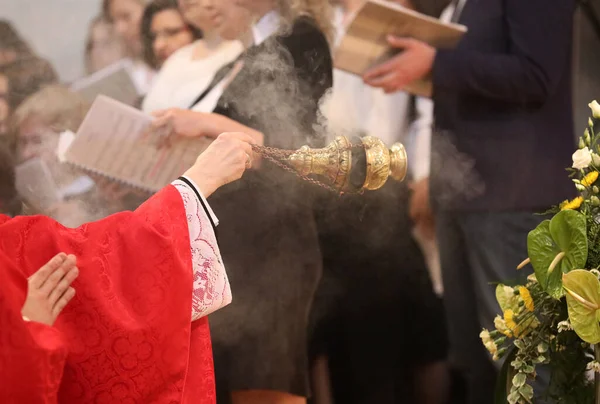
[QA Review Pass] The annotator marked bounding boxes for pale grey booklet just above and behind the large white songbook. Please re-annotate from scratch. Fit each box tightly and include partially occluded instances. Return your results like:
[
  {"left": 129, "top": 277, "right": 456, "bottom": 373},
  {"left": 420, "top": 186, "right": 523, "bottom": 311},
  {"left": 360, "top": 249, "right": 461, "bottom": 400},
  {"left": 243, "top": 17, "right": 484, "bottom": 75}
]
[{"left": 70, "top": 59, "right": 141, "bottom": 105}]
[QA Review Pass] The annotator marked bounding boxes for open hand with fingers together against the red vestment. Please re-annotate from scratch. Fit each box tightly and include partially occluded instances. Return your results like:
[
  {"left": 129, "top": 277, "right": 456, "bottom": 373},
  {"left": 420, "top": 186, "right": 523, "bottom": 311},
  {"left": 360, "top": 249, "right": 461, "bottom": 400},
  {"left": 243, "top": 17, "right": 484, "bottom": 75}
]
[{"left": 21, "top": 253, "right": 79, "bottom": 325}]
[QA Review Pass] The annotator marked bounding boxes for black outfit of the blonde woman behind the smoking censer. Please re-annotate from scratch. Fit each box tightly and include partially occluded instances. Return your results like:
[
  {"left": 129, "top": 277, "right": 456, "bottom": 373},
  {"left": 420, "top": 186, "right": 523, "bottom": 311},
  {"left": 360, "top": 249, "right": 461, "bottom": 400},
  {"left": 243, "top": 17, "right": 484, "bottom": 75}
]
[{"left": 204, "top": 18, "right": 332, "bottom": 403}]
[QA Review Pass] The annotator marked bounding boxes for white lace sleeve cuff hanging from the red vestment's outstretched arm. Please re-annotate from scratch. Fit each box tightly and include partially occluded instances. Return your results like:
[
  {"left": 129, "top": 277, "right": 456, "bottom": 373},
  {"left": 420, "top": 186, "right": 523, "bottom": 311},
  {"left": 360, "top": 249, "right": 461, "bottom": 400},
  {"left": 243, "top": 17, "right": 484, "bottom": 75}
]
[{"left": 173, "top": 179, "right": 231, "bottom": 321}]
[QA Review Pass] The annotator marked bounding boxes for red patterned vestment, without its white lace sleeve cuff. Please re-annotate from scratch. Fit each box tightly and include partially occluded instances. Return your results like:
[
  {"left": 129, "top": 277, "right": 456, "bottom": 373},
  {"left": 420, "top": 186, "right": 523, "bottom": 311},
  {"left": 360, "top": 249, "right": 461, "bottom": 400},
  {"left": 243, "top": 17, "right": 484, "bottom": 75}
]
[{"left": 0, "top": 186, "right": 215, "bottom": 404}]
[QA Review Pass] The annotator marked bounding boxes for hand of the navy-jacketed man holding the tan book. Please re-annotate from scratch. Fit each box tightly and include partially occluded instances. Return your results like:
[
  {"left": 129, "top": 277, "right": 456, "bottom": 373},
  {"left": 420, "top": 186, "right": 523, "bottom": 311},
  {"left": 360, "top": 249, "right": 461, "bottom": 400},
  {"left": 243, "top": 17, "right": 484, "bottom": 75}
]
[{"left": 363, "top": 35, "right": 436, "bottom": 94}]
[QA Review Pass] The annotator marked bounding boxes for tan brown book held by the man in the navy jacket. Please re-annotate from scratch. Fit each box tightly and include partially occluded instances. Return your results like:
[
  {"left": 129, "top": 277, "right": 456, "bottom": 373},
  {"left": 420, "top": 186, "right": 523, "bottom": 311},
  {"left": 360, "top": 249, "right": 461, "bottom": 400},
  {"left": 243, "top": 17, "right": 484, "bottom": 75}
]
[{"left": 334, "top": 0, "right": 467, "bottom": 97}]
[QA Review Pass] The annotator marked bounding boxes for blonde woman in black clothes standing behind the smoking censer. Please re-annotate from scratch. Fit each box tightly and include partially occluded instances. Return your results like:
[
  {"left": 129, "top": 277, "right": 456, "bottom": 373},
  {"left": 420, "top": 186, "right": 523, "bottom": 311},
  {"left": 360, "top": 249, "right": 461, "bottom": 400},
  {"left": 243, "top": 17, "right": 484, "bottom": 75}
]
[{"left": 155, "top": 0, "right": 333, "bottom": 404}]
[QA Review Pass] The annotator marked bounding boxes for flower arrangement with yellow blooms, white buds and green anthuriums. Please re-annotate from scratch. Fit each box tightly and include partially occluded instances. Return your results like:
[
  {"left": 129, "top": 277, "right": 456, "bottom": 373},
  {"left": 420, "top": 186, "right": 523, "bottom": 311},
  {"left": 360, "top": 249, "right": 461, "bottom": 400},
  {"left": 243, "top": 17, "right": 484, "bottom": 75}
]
[{"left": 480, "top": 101, "right": 600, "bottom": 404}]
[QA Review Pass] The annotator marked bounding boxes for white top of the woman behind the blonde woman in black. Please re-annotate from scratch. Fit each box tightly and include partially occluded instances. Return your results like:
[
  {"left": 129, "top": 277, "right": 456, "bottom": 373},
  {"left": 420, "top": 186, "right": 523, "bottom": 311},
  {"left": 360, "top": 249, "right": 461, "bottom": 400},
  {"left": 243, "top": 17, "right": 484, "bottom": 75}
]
[{"left": 142, "top": 41, "right": 243, "bottom": 113}]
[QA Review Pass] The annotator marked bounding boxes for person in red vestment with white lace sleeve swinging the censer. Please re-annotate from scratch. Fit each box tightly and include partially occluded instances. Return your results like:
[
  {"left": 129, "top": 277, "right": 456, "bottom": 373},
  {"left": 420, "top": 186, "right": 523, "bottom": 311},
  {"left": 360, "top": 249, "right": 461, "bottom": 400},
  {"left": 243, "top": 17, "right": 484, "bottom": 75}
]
[{"left": 0, "top": 134, "right": 252, "bottom": 404}]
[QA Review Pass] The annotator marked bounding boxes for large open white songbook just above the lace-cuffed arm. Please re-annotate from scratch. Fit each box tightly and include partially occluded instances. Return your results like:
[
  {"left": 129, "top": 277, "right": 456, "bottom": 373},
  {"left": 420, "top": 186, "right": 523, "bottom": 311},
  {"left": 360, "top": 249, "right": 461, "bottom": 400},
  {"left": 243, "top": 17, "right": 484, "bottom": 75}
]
[{"left": 65, "top": 95, "right": 212, "bottom": 193}]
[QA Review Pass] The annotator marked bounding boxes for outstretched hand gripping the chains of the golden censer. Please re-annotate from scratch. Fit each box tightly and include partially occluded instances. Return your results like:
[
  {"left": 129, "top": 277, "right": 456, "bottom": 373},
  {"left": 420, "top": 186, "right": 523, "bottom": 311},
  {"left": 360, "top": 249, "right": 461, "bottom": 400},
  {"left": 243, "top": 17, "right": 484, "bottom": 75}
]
[{"left": 184, "top": 132, "right": 254, "bottom": 198}]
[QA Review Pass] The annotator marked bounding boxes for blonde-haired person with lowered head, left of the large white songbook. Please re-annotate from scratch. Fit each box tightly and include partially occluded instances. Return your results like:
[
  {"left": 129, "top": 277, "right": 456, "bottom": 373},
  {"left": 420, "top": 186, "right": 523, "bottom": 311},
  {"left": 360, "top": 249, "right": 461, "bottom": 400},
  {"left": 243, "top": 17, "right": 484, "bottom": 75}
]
[{"left": 10, "top": 85, "right": 148, "bottom": 227}]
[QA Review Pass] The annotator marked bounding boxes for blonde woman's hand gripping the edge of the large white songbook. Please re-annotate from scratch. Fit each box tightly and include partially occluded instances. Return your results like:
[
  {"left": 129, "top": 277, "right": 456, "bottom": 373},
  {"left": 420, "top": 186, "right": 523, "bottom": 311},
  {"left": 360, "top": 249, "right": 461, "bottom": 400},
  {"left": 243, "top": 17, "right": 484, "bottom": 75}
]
[{"left": 152, "top": 108, "right": 219, "bottom": 137}]
